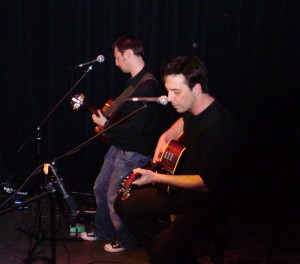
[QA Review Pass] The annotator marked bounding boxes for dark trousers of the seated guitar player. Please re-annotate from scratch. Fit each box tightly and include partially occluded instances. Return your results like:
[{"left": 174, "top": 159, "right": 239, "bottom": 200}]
[{"left": 115, "top": 187, "right": 224, "bottom": 264}]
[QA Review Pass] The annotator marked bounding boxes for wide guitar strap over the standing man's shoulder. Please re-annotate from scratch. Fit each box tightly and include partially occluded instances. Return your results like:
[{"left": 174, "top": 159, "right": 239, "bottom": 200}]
[{"left": 105, "top": 72, "right": 156, "bottom": 124}]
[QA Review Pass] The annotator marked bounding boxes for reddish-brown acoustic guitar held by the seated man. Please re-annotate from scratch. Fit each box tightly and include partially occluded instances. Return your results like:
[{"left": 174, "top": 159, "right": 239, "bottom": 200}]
[{"left": 119, "top": 133, "right": 186, "bottom": 201}]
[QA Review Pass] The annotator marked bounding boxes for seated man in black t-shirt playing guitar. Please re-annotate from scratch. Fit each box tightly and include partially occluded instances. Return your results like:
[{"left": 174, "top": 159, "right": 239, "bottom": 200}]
[{"left": 115, "top": 56, "right": 239, "bottom": 264}]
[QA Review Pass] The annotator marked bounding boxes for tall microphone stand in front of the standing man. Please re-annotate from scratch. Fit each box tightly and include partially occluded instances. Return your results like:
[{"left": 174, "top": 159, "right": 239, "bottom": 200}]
[{"left": 16, "top": 66, "right": 93, "bottom": 250}]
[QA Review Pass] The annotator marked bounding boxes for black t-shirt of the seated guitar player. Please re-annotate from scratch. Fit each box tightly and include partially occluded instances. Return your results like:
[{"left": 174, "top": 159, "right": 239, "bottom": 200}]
[{"left": 183, "top": 101, "right": 240, "bottom": 205}]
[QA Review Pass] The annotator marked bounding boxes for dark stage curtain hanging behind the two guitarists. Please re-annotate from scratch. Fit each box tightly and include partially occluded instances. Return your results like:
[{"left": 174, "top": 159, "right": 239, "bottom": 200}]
[{"left": 0, "top": 0, "right": 300, "bottom": 209}]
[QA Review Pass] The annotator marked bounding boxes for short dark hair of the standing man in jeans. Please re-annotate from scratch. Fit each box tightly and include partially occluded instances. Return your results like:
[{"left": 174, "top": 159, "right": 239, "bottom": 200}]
[{"left": 112, "top": 36, "right": 144, "bottom": 56}]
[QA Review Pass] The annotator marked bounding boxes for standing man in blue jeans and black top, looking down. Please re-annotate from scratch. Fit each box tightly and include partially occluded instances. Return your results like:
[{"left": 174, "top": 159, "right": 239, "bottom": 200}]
[{"left": 81, "top": 36, "right": 169, "bottom": 252}]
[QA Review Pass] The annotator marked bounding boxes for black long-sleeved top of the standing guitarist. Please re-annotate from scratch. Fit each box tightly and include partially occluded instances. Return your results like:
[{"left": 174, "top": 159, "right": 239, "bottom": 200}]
[{"left": 107, "top": 67, "right": 164, "bottom": 155}]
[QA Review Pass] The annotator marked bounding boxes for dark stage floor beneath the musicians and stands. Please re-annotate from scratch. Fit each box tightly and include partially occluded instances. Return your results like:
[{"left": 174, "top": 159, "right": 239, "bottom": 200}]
[{"left": 0, "top": 192, "right": 300, "bottom": 264}]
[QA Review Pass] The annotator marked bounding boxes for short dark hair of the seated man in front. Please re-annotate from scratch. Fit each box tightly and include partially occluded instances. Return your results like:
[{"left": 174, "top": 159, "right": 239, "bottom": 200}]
[{"left": 161, "top": 56, "right": 208, "bottom": 93}]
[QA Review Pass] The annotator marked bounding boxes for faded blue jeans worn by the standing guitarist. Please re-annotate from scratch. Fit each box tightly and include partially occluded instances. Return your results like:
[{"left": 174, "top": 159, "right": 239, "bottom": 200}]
[{"left": 94, "top": 146, "right": 150, "bottom": 249}]
